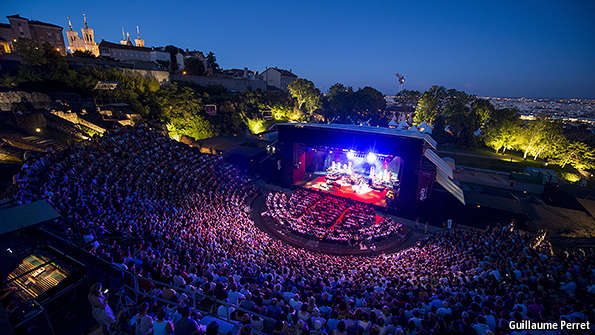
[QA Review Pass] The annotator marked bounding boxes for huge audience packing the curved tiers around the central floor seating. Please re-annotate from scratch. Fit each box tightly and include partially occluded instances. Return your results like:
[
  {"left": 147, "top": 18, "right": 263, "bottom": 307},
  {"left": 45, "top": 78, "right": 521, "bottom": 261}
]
[{"left": 16, "top": 127, "right": 595, "bottom": 335}]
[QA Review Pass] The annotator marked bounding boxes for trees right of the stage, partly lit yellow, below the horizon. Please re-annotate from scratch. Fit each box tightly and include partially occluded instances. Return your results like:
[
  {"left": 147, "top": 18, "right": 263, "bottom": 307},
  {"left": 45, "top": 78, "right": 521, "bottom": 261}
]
[{"left": 410, "top": 86, "right": 595, "bottom": 171}]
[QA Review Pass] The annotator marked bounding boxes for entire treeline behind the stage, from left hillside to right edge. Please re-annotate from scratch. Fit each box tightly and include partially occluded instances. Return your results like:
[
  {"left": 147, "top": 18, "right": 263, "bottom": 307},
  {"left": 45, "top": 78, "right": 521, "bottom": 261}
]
[{"left": 0, "top": 40, "right": 595, "bottom": 175}]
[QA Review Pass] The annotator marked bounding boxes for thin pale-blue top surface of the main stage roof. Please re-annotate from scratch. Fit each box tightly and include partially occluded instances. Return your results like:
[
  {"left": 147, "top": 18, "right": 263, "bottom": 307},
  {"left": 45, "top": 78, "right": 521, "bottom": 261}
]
[{"left": 276, "top": 123, "right": 437, "bottom": 149}]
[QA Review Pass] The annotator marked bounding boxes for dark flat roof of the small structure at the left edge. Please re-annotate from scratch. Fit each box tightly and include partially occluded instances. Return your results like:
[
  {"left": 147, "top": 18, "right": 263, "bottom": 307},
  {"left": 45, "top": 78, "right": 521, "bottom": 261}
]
[{"left": 0, "top": 200, "right": 60, "bottom": 234}]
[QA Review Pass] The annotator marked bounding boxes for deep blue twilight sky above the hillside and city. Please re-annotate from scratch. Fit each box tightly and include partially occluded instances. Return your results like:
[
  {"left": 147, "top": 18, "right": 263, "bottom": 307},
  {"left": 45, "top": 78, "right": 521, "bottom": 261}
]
[{"left": 0, "top": 0, "right": 595, "bottom": 98}]
